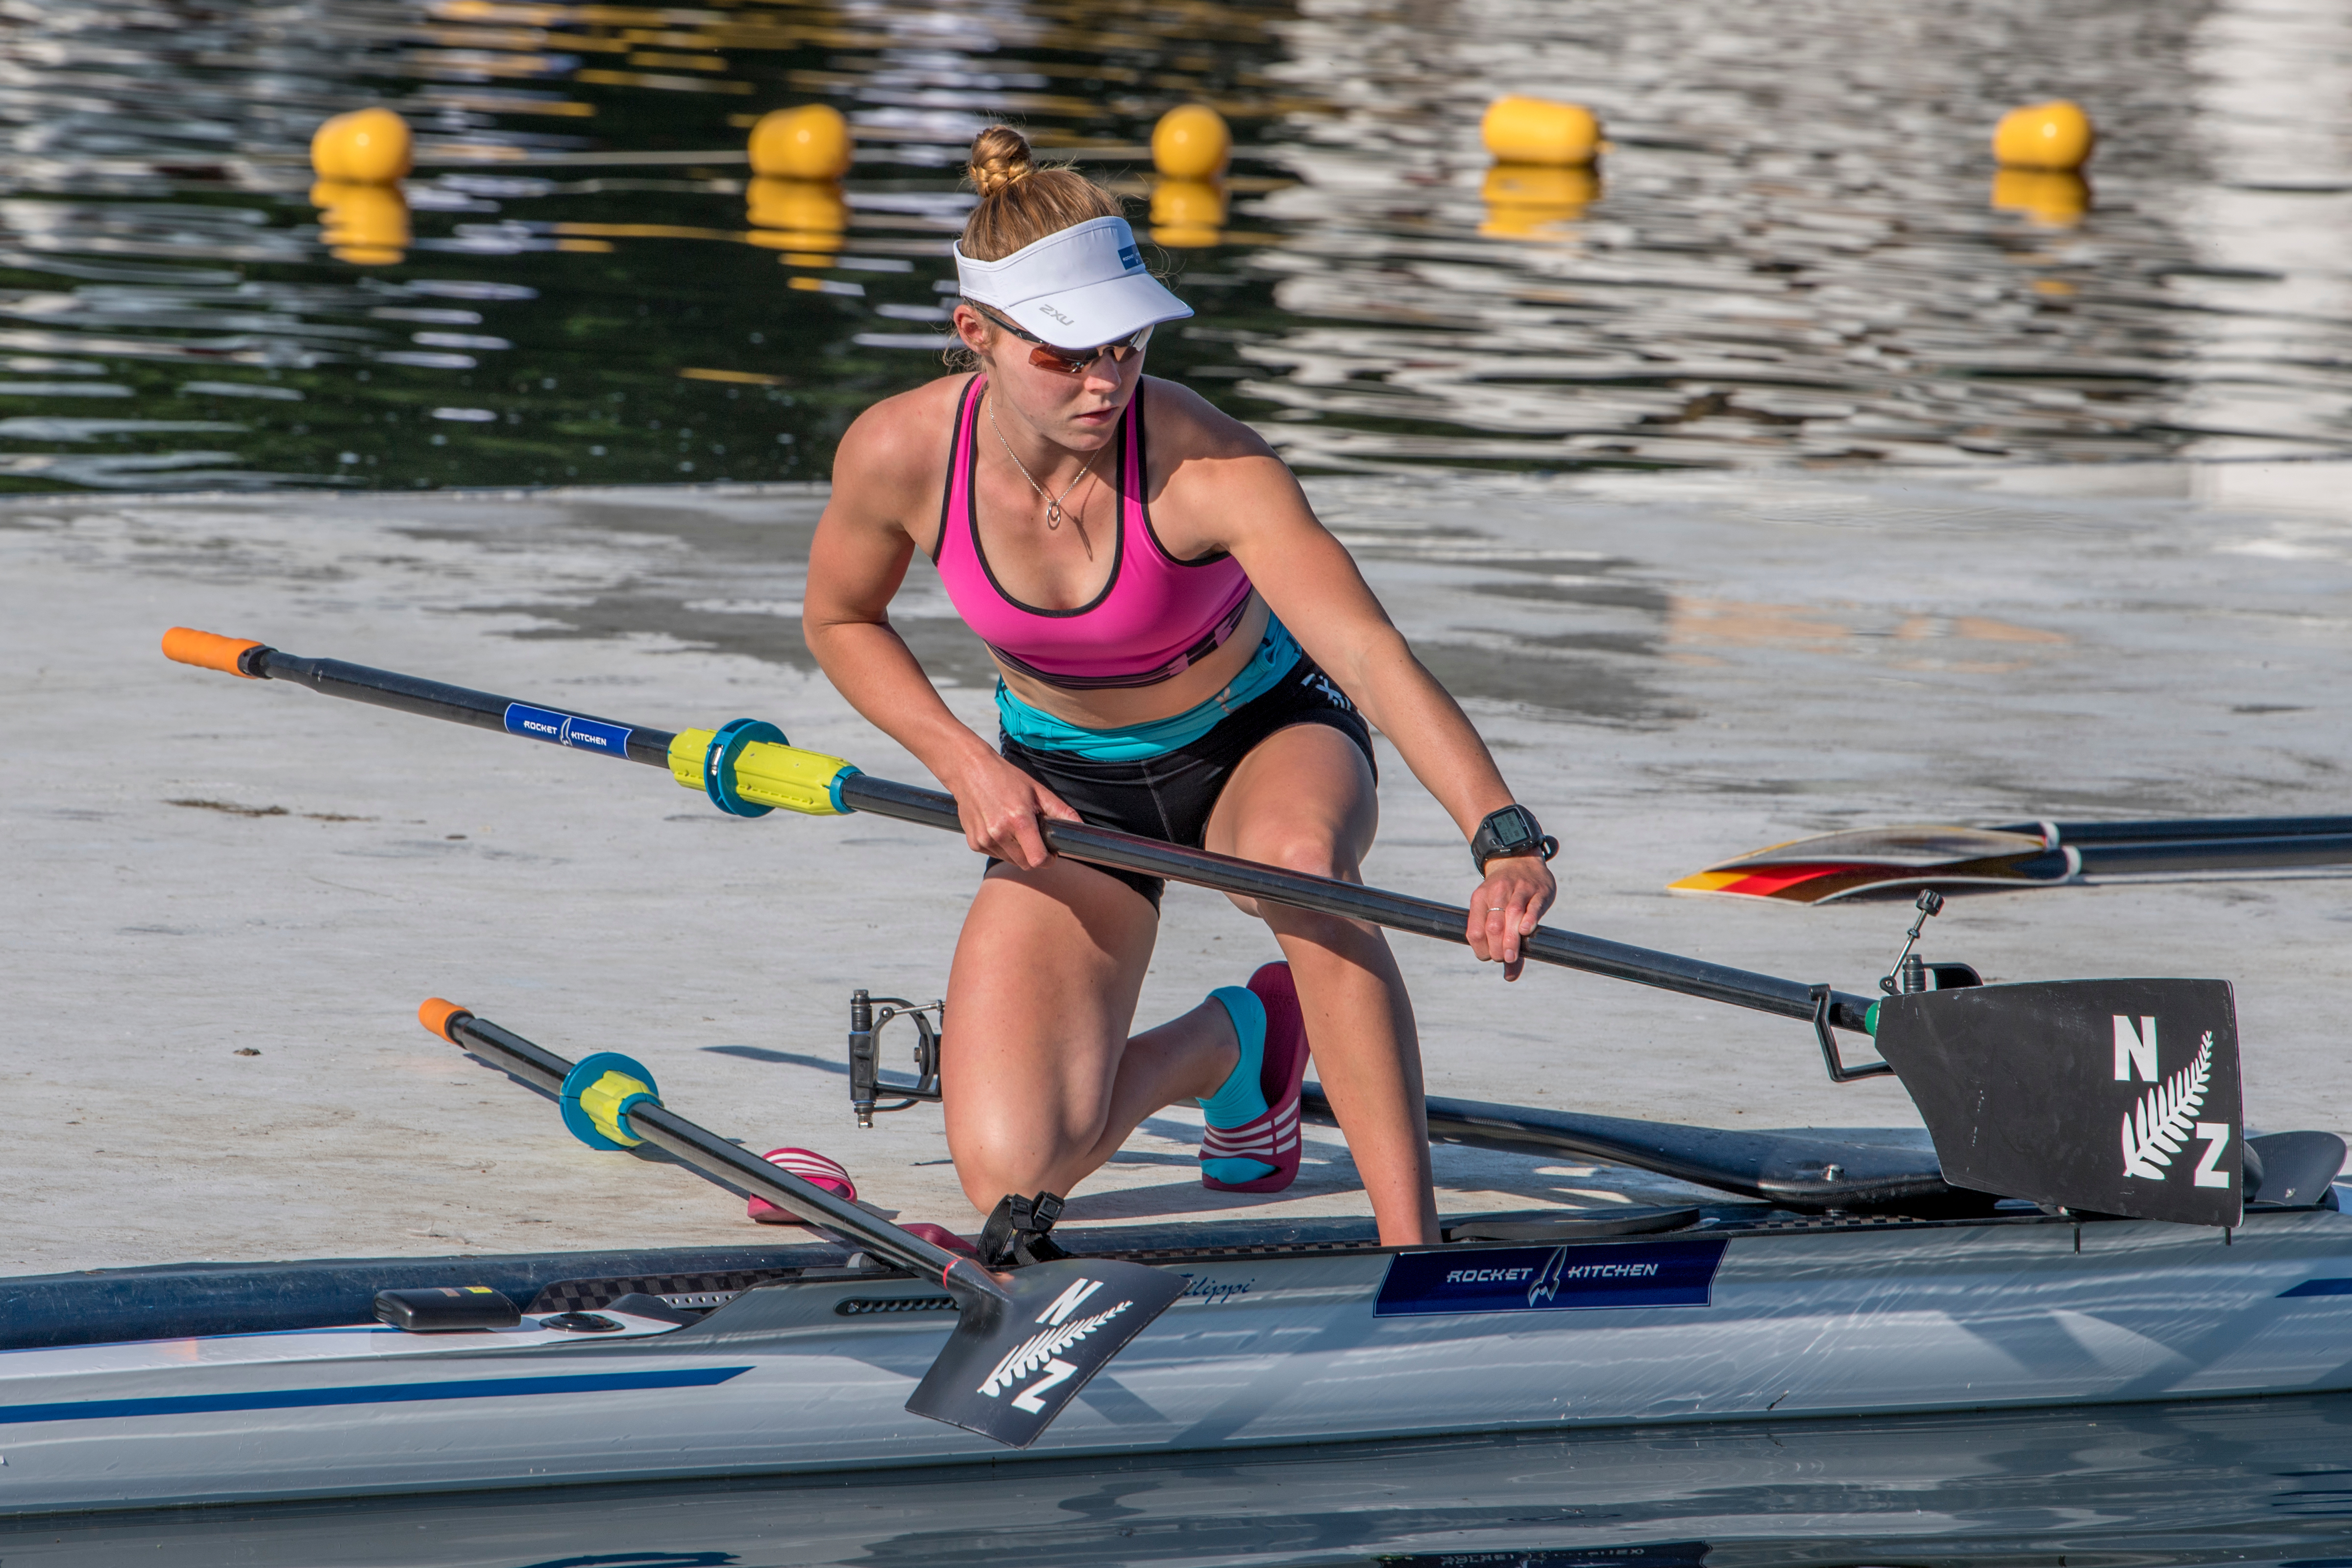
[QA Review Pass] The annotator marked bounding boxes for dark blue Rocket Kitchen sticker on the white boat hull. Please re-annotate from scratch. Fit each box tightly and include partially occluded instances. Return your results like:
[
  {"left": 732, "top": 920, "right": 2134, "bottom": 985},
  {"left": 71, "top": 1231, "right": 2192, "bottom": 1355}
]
[{"left": 1373, "top": 1239, "right": 1724, "bottom": 1317}]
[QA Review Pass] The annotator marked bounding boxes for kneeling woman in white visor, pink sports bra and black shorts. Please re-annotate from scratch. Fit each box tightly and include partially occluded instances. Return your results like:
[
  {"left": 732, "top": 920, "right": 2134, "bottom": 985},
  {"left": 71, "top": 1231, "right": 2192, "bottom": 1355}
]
[{"left": 805, "top": 127, "right": 1555, "bottom": 1265}]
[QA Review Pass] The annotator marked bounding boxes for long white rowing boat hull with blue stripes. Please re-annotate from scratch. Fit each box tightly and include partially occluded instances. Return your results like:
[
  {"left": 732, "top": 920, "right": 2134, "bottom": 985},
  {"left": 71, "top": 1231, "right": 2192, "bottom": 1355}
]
[{"left": 0, "top": 1211, "right": 2352, "bottom": 1514}]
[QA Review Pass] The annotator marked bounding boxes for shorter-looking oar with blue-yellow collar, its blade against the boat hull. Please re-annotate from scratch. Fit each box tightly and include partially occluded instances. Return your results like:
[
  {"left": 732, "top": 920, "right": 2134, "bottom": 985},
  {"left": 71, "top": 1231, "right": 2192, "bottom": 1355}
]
[{"left": 416, "top": 997, "right": 1188, "bottom": 1448}]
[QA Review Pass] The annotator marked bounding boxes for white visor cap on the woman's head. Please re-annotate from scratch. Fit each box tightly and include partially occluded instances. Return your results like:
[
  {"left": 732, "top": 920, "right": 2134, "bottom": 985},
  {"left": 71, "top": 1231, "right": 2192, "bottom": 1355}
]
[{"left": 955, "top": 219, "right": 1193, "bottom": 348}]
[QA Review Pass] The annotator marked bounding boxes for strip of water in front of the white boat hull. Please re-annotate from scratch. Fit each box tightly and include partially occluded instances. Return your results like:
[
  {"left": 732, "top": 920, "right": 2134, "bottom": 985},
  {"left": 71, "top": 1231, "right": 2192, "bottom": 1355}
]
[{"left": 14, "top": 1396, "right": 2352, "bottom": 1568}]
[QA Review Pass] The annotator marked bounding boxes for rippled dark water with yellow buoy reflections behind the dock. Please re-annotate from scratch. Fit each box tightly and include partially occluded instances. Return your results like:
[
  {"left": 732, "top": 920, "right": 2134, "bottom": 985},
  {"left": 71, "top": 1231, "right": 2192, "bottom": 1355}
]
[{"left": 0, "top": 0, "right": 2352, "bottom": 487}]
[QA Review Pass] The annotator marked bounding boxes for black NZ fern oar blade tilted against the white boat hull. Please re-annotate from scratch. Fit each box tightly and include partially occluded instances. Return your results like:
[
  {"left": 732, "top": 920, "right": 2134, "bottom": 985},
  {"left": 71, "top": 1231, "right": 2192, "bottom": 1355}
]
[{"left": 906, "top": 1258, "right": 1185, "bottom": 1448}]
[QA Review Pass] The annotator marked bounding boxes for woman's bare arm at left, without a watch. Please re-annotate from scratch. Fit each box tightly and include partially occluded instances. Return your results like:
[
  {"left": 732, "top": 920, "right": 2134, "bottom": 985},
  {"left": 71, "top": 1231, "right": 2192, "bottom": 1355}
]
[{"left": 800, "top": 388, "right": 1077, "bottom": 870}]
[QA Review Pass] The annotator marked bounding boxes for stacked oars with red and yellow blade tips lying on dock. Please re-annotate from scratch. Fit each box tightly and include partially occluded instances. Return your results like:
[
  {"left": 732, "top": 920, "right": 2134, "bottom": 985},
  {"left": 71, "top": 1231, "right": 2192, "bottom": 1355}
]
[{"left": 1667, "top": 816, "right": 2352, "bottom": 903}]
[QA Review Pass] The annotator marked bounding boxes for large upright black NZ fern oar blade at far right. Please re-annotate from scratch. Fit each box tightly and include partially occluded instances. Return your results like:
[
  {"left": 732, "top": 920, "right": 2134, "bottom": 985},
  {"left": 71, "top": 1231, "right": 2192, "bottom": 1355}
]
[{"left": 1877, "top": 980, "right": 2244, "bottom": 1225}]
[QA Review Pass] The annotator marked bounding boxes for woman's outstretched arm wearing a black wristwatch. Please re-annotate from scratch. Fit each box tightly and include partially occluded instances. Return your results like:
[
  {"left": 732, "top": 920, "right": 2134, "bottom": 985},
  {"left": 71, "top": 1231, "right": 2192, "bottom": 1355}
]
[{"left": 1152, "top": 386, "right": 1555, "bottom": 976}]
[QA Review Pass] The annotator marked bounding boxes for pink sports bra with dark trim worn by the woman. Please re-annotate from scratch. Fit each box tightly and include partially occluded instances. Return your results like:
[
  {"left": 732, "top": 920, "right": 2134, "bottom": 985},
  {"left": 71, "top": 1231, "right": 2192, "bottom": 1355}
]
[{"left": 934, "top": 376, "right": 1249, "bottom": 691}]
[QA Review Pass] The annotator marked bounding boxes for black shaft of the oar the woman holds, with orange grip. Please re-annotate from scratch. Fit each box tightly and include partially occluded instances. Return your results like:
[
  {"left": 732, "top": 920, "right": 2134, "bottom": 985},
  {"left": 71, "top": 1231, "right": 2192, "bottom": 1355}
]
[{"left": 162, "top": 628, "right": 1886, "bottom": 1053}]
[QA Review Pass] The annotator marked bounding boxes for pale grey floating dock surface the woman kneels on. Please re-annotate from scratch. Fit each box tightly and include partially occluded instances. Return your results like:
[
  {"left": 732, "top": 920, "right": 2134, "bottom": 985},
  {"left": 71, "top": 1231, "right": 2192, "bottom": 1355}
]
[{"left": 0, "top": 463, "right": 2352, "bottom": 1274}]
